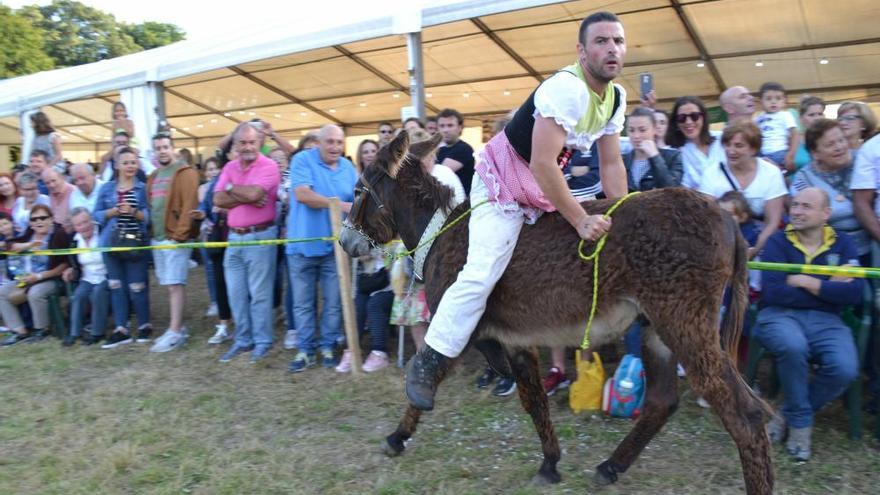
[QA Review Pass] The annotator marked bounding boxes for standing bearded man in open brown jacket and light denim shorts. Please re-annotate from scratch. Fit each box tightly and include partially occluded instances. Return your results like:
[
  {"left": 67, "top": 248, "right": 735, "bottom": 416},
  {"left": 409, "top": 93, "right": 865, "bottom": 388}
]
[{"left": 147, "top": 133, "right": 199, "bottom": 352}]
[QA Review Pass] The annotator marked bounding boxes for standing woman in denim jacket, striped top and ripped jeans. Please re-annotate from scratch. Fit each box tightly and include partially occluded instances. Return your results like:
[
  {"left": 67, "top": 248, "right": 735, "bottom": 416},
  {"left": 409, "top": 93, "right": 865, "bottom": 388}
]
[{"left": 94, "top": 147, "right": 152, "bottom": 349}]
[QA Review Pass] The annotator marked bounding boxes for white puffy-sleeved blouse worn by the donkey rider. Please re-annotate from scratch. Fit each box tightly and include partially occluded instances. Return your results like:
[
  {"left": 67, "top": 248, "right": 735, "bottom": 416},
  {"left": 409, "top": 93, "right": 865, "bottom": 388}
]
[{"left": 534, "top": 71, "right": 626, "bottom": 152}]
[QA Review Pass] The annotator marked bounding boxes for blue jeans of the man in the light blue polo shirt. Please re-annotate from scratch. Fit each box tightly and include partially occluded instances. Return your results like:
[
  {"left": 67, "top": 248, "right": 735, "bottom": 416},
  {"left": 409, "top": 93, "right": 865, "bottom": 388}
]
[{"left": 287, "top": 253, "right": 342, "bottom": 354}]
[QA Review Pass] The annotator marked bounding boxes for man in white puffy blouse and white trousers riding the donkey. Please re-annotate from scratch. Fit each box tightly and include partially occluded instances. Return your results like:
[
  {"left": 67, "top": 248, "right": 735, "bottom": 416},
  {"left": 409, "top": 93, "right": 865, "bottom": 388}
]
[{"left": 406, "top": 12, "right": 627, "bottom": 410}]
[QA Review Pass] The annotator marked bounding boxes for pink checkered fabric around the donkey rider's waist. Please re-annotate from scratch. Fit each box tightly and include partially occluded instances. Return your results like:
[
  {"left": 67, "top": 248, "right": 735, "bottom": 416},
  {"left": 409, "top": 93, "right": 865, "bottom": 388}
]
[{"left": 476, "top": 132, "right": 556, "bottom": 223}]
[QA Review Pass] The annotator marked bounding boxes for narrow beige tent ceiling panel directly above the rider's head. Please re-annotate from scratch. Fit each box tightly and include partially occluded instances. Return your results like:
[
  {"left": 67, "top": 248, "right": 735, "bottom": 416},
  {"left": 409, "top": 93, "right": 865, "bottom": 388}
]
[{"left": 481, "top": 0, "right": 669, "bottom": 30}]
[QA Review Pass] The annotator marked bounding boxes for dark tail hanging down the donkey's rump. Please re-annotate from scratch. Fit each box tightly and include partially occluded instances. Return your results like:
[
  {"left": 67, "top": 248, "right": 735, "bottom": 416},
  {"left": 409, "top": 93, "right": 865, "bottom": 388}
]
[{"left": 721, "top": 215, "right": 749, "bottom": 363}]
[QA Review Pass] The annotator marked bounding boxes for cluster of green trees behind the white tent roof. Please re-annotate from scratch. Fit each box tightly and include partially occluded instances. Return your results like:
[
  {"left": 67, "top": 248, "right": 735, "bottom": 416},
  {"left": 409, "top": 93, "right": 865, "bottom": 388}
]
[{"left": 0, "top": 0, "right": 186, "bottom": 78}]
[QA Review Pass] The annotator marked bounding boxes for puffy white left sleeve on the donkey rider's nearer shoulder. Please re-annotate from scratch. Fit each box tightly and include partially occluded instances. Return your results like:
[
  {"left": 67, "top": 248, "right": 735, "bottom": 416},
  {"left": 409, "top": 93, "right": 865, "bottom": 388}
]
[{"left": 534, "top": 72, "right": 590, "bottom": 134}]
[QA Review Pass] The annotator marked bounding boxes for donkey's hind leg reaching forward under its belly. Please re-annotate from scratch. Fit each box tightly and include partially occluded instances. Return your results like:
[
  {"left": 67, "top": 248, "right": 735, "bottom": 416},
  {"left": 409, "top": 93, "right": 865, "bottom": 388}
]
[{"left": 595, "top": 327, "right": 678, "bottom": 485}]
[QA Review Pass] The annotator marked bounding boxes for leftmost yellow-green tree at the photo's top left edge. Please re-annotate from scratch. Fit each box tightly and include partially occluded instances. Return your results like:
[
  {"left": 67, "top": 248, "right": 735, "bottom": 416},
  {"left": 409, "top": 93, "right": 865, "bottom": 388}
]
[{"left": 0, "top": 5, "right": 55, "bottom": 79}]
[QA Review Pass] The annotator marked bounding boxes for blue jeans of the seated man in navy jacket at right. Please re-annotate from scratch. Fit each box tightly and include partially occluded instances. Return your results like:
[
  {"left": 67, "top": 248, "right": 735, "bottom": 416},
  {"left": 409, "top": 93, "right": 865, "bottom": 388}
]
[{"left": 754, "top": 306, "right": 858, "bottom": 428}]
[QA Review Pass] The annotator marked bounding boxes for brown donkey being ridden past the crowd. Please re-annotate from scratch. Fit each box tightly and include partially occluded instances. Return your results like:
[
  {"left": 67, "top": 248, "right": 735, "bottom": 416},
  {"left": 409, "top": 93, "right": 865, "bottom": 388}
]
[{"left": 340, "top": 133, "right": 773, "bottom": 494}]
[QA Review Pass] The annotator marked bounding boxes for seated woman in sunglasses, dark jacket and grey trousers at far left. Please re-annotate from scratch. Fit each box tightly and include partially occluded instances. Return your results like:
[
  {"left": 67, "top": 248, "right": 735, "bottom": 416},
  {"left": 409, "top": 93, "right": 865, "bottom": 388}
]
[{"left": 0, "top": 205, "right": 70, "bottom": 346}]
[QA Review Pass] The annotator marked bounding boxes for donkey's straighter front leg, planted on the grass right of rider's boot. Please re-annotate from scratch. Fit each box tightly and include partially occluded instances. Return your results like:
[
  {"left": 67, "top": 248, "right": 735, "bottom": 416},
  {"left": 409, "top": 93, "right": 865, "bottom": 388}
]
[{"left": 508, "top": 348, "right": 562, "bottom": 485}]
